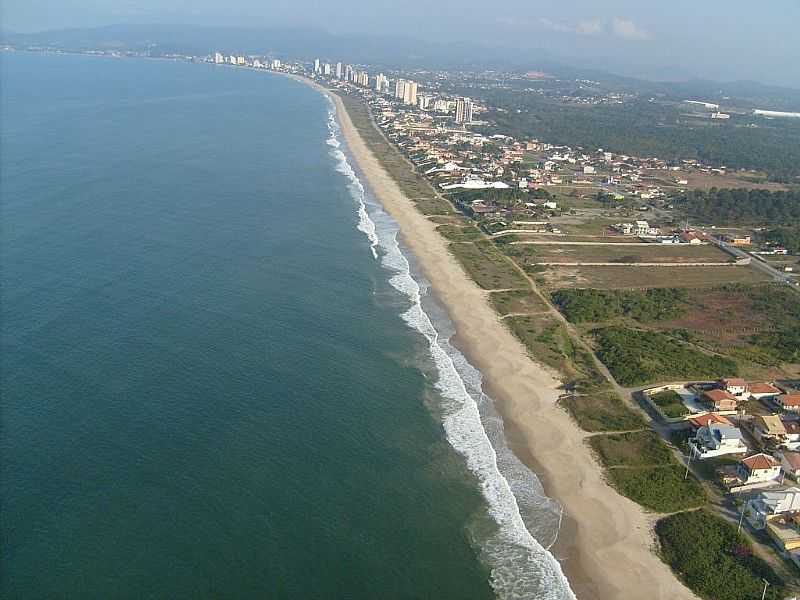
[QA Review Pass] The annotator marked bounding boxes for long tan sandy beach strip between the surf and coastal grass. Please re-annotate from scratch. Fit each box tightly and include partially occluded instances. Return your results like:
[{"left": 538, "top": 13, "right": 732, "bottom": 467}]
[{"left": 301, "top": 80, "right": 696, "bottom": 600}]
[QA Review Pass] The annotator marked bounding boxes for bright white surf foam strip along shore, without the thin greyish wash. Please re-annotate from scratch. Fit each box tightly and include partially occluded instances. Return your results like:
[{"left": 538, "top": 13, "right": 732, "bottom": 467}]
[{"left": 327, "top": 103, "right": 575, "bottom": 600}]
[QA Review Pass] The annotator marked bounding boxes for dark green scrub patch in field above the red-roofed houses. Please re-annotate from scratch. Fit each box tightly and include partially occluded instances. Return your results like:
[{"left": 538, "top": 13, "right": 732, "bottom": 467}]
[{"left": 592, "top": 327, "right": 738, "bottom": 386}]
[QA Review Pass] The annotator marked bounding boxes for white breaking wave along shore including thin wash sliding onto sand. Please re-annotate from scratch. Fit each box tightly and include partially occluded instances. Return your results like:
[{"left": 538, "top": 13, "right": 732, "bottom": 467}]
[{"left": 327, "top": 103, "right": 575, "bottom": 600}]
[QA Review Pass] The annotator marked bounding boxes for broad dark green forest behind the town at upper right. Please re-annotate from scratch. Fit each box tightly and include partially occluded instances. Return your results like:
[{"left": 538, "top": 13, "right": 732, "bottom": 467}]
[{"left": 473, "top": 90, "right": 800, "bottom": 183}]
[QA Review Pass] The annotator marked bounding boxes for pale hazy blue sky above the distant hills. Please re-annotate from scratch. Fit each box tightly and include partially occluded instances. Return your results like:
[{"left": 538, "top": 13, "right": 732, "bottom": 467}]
[{"left": 0, "top": 0, "right": 800, "bottom": 88}]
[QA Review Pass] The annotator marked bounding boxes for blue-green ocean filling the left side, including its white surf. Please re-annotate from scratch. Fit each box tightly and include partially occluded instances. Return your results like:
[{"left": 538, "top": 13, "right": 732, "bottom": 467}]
[{"left": 0, "top": 53, "right": 573, "bottom": 600}]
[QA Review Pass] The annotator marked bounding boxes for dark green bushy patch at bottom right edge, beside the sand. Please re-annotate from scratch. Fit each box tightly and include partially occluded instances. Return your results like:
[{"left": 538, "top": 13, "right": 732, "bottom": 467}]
[{"left": 656, "top": 510, "right": 786, "bottom": 600}]
